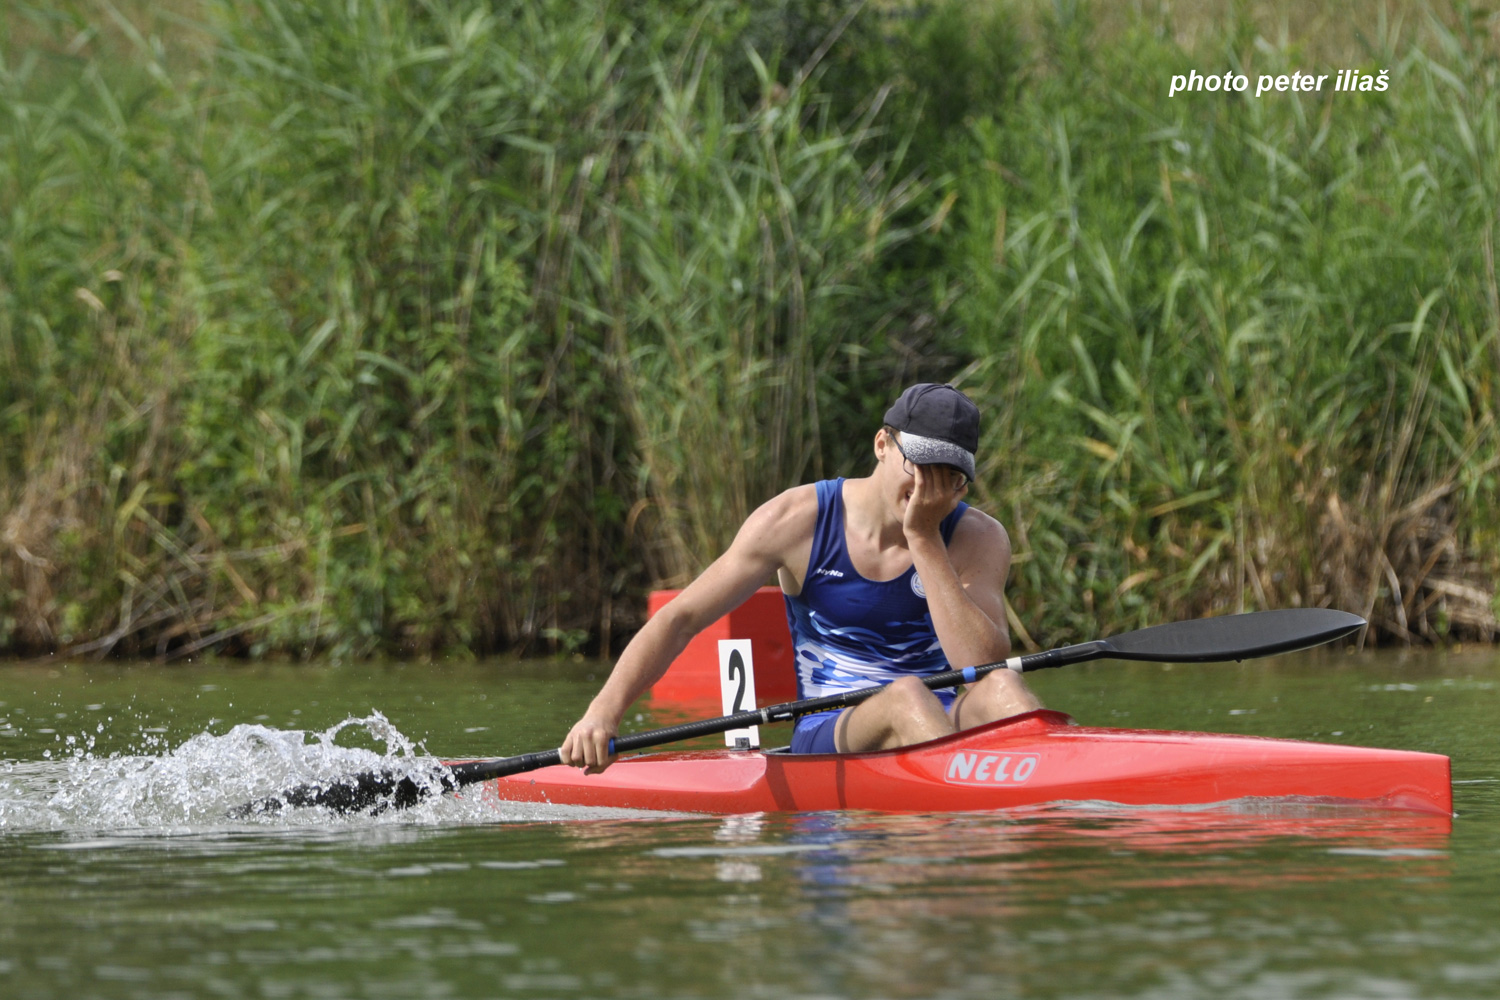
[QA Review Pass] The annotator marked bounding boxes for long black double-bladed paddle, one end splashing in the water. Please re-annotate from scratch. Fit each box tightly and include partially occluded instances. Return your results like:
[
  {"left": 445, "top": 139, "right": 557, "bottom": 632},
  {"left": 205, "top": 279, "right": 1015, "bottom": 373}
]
[{"left": 230, "top": 607, "right": 1365, "bottom": 819}]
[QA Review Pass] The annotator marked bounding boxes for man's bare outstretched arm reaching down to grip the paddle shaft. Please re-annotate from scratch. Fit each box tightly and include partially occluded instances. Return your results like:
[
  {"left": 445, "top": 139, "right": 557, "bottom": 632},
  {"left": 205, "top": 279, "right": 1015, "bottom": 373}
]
[{"left": 561, "top": 486, "right": 818, "bottom": 774}]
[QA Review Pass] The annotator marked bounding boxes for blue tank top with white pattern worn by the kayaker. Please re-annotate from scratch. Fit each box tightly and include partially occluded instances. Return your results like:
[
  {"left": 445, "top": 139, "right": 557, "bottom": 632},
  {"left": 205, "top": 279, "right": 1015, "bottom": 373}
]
[{"left": 783, "top": 478, "right": 969, "bottom": 719}]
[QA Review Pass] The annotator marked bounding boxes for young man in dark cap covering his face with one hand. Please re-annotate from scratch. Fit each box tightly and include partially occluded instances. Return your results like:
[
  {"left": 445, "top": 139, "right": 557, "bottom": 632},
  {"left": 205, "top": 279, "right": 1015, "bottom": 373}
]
[{"left": 561, "top": 382, "right": 1041, "bottom": 772}]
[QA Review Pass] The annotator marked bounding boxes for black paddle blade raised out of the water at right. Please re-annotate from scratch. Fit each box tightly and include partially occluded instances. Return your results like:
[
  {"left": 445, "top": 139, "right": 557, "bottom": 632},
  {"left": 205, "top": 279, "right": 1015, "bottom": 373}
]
[{"left": 1101, "top": 607, "right": 1365, "bottom": 663}]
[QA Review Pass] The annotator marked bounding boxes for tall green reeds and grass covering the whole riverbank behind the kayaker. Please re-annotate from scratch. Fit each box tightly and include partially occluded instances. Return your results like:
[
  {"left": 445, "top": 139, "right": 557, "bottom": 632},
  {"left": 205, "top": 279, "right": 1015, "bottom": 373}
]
[{"left": 0, "top": 0, "right": 1500, "bottom": 658}]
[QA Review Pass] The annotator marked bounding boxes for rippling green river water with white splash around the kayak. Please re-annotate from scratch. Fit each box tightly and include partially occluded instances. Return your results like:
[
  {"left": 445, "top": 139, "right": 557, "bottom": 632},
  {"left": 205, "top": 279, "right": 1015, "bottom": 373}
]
[{"left": 0, "top": 649, "right": 1500, "bottom": 1000}]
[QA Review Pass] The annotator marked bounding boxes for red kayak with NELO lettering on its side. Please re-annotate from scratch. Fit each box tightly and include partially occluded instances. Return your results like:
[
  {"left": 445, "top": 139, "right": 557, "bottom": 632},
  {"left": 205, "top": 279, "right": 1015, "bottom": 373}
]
[{"left": 482, "top": 709, "right": 1454, "bottom": 816}]
